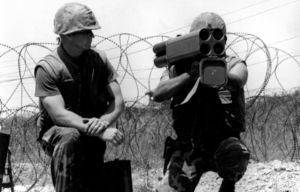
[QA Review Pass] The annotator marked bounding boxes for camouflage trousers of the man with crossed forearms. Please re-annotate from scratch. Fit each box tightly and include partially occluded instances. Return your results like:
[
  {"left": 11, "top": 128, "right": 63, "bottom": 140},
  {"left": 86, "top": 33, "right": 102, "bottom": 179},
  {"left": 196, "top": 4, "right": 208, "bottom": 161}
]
[{"left": 41, "top": 126, "right": 105, "bottom": 192}]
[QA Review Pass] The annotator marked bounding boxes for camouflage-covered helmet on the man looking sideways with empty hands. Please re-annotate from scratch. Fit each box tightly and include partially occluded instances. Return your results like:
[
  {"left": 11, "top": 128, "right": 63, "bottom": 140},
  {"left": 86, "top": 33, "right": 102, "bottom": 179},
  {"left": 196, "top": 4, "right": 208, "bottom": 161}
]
[{"left": 54, "top": 3, "right": 101, "bottom": 35}]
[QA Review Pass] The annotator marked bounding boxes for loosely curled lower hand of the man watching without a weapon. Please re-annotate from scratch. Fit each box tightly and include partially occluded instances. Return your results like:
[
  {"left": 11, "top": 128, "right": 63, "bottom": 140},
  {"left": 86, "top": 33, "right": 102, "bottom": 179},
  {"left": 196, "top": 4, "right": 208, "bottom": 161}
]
[{"left": 99, "top": 128, "right": 124, "bottom": 146}]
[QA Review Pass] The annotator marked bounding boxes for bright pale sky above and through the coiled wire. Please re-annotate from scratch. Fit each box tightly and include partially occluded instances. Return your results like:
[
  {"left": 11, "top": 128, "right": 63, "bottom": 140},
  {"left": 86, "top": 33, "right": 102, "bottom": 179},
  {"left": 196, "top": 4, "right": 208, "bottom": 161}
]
[{"left": 0, "top": 0, "right": 300, "bottom": 109}]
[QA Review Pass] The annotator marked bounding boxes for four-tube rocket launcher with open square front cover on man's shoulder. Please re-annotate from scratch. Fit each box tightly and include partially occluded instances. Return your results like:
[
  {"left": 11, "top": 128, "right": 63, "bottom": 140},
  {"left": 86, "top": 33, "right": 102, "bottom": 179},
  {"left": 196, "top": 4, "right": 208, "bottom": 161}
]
[{"left": 153, "top": 28, "right": 227, "bottom": 87}]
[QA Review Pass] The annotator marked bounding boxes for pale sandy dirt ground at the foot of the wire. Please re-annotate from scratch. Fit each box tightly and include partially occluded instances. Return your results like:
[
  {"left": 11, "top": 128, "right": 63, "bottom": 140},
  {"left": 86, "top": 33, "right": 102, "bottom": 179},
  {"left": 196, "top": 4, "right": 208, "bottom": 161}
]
[{"left": 3, "top": 160, "right": 300, "bottom": 192}]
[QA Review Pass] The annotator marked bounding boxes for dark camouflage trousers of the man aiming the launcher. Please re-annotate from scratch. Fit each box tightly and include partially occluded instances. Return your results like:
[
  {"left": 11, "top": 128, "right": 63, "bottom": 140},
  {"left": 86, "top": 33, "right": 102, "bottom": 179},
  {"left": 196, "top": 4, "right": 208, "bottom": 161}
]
[{"left": 156, "top": 137, "right": 250, "bottom": 192}]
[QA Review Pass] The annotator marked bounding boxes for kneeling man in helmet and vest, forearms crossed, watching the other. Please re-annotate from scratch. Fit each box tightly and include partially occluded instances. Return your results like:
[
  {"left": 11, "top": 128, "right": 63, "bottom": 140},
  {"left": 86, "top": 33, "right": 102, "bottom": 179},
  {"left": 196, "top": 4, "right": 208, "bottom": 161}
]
[{"left": 35, "top": 3, "right": 124, "bottom": 192}]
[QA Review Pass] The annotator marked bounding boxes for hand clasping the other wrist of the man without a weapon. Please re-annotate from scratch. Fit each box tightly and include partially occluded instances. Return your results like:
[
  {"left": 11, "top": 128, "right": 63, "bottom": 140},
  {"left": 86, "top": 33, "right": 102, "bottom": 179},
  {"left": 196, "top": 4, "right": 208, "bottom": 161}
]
[{"left": 85, "top": 118, "right": 109, "bottom": 136}]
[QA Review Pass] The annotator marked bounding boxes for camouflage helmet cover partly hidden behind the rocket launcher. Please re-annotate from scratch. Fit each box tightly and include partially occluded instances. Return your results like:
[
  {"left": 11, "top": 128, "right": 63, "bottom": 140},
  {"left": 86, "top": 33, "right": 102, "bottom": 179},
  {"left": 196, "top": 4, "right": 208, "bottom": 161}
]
[{"left": 190, "top": 12, "right": 226, "bottom": 34}]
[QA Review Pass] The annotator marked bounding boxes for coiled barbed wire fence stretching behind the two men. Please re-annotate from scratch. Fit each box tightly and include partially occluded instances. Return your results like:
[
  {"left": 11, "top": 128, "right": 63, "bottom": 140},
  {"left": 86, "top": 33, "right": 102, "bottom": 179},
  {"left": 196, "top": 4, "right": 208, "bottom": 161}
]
[{"left": 0, "top": 33, "right": 300, "bottom": 191}]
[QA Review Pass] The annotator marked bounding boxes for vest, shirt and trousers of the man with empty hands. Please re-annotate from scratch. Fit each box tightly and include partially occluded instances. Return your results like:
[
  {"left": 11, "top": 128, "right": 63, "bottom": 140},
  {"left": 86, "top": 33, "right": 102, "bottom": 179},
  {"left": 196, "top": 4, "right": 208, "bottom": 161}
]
[{"left": 35, "top": 42, "right": 118, "bottom": 192}]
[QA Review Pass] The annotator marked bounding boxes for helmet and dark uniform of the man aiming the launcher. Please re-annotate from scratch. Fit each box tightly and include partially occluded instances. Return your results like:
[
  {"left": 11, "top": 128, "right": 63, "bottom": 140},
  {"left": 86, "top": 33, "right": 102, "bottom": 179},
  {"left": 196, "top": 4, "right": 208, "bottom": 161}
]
[{"left": 156, "top": 13, "right": 250, "bottom": 192}]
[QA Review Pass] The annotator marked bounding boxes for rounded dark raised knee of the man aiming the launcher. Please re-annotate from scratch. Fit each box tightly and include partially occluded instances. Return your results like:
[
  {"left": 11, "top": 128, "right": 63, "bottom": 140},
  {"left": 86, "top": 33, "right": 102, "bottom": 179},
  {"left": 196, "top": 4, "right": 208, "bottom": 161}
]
[{"left": 214, "top": 137, "right": 250, "bottom": 182}]
